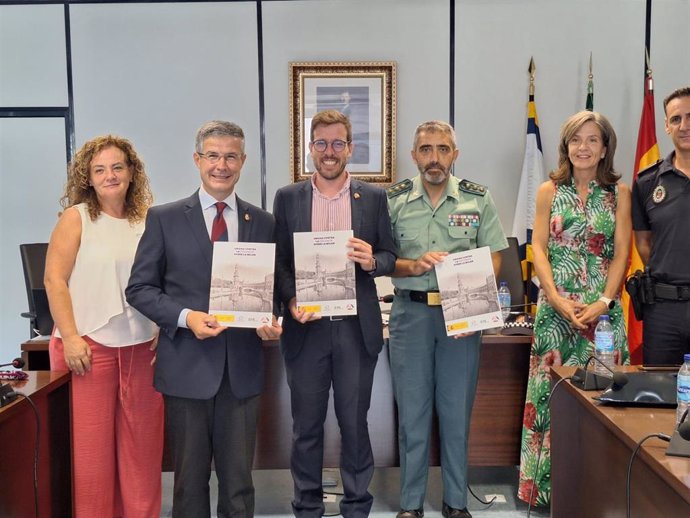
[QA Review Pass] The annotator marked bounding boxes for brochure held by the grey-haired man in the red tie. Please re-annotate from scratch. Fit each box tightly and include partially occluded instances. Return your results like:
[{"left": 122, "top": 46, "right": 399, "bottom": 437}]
[{"left": 208, "top": 241, "right": 276, "bottom": 328}]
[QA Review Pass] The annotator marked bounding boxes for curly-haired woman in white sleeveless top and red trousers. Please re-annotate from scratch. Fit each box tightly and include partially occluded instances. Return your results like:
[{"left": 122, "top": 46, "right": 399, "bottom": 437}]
[{"left": 45, "top": 135, "right": 163, "bottom": 518}]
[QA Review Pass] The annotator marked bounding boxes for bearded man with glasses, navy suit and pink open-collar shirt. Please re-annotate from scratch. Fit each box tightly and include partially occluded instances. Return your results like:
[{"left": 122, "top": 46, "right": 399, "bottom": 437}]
[{"left": 273, "top": 110, "right": 395, "bottom": 518}]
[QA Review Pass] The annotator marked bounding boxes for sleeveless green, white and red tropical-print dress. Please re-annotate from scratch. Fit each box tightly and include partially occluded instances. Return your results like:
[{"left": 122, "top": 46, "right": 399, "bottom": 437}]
[{"left": 518, "top": 181, "right": 628, "bottom": 506}]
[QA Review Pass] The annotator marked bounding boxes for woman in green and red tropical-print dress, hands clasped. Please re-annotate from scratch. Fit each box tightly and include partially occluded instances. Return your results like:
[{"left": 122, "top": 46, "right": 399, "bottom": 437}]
[{"left": 518, "top": 111, "right": 632, "bottom": 506}]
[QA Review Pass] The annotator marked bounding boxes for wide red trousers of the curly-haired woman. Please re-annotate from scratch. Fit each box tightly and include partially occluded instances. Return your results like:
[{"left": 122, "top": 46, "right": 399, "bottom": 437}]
[{"left": 50, "top": 336, "right": 163, "bottom": 518}]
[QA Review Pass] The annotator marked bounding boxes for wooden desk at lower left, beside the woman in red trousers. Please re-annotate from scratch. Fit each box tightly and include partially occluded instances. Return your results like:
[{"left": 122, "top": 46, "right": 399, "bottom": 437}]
[{"left": 0, "top": 371, "right": 72, "bottom": 518}]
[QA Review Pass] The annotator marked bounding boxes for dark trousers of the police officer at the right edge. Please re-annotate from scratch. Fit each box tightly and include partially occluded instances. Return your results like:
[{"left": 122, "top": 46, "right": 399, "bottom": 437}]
[{"left": 642, "top": 300, "right": 690, "bottom": 365}]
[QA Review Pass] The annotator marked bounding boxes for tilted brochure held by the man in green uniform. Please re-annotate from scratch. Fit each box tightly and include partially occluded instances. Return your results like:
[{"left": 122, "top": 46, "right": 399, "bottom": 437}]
[{"left": 436, "top": 246, "right": 503, "bottom": 336}]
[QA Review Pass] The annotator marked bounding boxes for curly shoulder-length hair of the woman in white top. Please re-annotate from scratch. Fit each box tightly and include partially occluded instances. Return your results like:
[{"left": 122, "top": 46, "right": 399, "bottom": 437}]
[{"left": 60, "top": 135, "right": 153, "bottom": 223}]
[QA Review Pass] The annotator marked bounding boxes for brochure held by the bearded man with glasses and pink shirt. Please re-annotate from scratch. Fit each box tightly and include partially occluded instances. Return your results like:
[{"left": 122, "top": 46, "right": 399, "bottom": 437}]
[{"left": 294, "top": 230, "right": 357, "bottom": 317}]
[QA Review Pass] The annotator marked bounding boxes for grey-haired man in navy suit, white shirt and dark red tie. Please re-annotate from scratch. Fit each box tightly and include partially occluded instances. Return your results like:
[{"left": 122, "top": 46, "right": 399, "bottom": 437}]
[{"left": 125, "top": 121, "right": 282, "bottom": 518}]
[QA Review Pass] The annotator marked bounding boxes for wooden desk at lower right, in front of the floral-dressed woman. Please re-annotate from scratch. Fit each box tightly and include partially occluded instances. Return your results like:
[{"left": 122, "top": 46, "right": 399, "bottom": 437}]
[{"left": 551, "top": 367, "right": 690, "bottom": 518}]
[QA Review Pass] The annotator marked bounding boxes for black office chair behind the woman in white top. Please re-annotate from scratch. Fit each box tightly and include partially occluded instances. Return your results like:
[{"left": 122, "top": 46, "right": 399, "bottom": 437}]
[{"left": 19, "top": 243, "right": 53, "bottom": 338}]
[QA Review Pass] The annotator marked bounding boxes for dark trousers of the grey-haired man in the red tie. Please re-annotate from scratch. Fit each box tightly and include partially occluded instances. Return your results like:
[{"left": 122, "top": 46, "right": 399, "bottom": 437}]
[{"left": 164, "top": 368, "right": 259, "bottom": 518}]
